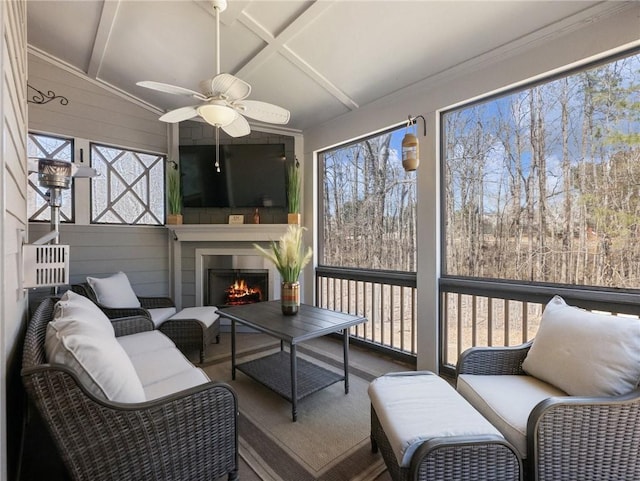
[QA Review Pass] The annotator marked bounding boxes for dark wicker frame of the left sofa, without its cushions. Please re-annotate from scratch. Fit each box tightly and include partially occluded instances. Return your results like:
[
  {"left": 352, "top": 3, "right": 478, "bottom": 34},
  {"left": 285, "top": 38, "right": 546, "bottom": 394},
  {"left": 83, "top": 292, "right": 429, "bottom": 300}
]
[{"left": 22, "top": 299, "right": 238, "bottom": 481}]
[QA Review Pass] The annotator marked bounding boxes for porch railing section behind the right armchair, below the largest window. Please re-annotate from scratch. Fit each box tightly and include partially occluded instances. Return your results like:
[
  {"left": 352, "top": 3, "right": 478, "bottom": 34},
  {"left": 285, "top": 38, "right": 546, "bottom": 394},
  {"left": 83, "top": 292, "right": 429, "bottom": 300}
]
[{"left": 439, "top": 278, "right": 640, "bottom": 372}]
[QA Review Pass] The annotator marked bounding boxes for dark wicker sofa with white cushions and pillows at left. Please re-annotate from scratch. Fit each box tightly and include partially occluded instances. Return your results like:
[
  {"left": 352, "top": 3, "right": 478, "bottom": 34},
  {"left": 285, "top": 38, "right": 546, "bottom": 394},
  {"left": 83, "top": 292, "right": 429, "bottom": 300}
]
[{"left": 22, "top": 295, "right": 238, "bottom": 481}]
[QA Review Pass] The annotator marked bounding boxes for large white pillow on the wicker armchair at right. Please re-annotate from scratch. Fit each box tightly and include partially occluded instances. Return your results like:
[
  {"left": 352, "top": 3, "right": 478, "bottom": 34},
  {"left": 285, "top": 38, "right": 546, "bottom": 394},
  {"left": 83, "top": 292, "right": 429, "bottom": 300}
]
[{"left": 522, "top": 296, "right": 640, "bottom": 396}]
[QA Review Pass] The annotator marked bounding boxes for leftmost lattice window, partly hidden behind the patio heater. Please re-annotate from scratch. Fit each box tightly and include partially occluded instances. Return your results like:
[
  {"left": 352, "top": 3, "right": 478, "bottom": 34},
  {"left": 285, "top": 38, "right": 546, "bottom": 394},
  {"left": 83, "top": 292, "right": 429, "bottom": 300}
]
[{"left": 27, "top": 133, "right": 74, "bottom": 222}]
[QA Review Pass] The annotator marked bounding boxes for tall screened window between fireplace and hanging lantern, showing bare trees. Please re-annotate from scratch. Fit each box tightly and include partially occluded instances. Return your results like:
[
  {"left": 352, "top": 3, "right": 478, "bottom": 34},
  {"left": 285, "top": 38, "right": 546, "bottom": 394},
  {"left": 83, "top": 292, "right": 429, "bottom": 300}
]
[{"left": 318, "top": 128, "right": 416, "bottom": 272}]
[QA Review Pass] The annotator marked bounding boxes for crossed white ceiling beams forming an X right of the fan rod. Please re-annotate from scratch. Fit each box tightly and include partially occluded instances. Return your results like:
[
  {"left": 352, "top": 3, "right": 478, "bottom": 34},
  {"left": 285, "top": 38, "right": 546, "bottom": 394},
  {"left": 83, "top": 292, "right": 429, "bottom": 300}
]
[{"left": 235, "top": 1, "right": 359, "bottom": 110}]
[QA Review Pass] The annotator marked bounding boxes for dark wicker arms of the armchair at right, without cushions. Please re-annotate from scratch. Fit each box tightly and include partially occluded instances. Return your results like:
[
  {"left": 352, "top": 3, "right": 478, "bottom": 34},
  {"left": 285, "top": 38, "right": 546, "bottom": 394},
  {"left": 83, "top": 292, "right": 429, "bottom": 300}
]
[{"left": 457, "top": 342, "right": 640, "bottom": 481}]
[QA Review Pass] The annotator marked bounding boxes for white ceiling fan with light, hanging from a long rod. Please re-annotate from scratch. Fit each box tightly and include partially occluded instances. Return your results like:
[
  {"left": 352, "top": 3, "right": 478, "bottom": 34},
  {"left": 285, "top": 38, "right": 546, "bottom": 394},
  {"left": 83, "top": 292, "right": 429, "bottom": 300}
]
[{"left": 137, "top": 0, "right": 290, "bottom": 139}]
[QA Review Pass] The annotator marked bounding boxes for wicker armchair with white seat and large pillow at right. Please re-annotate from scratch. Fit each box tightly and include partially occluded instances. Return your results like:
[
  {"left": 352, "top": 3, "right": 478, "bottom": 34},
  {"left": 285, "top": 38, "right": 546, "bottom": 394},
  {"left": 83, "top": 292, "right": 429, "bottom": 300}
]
[{"left": 457, "top": 297, "right": 640, "bottom": 481}]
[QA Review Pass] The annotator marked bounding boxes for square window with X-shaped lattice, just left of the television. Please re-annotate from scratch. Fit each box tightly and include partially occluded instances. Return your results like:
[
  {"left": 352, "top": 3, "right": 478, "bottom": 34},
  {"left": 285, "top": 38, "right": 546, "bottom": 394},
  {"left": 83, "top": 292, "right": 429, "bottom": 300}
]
[{"left": 91, "top": 144, "right": 165, "bottom": 225}]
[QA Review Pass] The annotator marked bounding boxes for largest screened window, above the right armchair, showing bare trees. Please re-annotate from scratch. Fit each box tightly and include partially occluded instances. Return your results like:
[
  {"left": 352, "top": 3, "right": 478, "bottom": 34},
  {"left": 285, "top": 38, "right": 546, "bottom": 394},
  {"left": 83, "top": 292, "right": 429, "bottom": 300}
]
[{"left": 442, "top": 51, "right": 640, "bottom": 288}]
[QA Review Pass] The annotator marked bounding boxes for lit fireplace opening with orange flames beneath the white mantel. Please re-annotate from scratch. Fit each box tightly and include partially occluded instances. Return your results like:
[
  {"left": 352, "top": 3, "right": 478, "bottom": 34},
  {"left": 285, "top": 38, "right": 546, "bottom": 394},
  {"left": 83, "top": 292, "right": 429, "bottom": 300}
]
[{"left": 207, "top": 269, "right": 269, "bottom": 306}]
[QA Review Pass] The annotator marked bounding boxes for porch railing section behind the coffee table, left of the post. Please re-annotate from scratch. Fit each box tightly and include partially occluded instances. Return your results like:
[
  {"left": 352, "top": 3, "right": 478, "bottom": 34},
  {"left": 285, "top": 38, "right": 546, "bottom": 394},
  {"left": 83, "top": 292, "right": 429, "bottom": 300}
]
[{"left": 316, "top": 266, "right": 417, "bottom": 357}]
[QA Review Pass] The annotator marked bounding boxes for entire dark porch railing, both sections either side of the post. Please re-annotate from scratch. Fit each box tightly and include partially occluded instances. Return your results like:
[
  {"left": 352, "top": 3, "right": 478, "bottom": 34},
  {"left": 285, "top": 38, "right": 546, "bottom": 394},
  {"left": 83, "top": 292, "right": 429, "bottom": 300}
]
[{"left": 316, "top": 272, "right": 640, "bottom": 373}]
